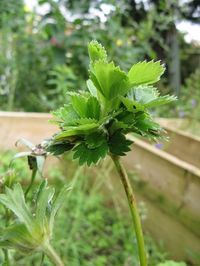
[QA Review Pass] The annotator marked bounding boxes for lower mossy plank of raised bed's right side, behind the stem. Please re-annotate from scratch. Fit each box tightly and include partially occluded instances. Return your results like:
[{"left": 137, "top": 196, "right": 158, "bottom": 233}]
[{"left": 103, "top": 163, "right": 200, "bottom": 266}]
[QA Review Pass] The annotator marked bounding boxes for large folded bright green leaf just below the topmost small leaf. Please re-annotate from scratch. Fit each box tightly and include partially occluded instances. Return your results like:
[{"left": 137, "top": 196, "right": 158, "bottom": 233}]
[{"left": 90, "top": 61, "right": 129, "bottom": 100}]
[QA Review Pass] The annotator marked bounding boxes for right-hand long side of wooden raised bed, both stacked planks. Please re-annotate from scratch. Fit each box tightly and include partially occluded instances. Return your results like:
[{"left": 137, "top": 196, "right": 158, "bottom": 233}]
[{"left": 124, "top": 136, "right": 200, "bottom": 265}]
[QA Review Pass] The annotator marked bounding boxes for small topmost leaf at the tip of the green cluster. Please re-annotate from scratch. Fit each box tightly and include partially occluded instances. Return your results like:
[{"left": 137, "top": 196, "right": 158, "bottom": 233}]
[{"left": 88, "top": 41, "right": 107, "bottom": 63}]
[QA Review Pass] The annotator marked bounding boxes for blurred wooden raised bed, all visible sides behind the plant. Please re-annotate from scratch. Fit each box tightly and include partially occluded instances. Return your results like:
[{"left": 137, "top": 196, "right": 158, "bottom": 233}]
[{"left": 0, "top": 112, "right": 200, "bottom": 266}]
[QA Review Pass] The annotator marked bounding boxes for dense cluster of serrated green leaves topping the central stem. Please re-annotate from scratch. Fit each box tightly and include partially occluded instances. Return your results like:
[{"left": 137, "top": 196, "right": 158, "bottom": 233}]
[{"left": 47, "top": 41, "right": 175, "bottom": 165}]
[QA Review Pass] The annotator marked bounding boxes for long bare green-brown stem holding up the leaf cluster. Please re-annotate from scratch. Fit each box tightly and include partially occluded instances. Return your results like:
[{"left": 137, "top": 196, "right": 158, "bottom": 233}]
[{"left": 111, "top": 155, "right": 147, "bottom": 266}]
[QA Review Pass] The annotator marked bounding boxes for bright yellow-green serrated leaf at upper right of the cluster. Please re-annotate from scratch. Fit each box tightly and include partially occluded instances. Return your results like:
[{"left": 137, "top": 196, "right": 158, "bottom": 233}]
[{"left": 128, "top": 61, "right": 165, "bottom": 86}]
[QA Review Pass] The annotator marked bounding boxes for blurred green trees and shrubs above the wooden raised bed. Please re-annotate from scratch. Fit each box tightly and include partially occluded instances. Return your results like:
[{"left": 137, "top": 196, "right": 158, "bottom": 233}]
[{"left": 0, "top": 0, "right": 200, "bottom": 117}]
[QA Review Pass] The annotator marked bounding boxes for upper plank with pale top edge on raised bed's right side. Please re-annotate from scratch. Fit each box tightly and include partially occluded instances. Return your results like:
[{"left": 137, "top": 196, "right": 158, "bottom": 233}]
[{"left": 124, "top": 136, "right": 200, "bottom": 236}]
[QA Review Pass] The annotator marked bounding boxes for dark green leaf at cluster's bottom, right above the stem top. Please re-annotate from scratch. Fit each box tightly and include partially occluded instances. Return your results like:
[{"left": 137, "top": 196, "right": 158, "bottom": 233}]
[{"left": 109, "top": 131, "right": 133, "bottom": 156}]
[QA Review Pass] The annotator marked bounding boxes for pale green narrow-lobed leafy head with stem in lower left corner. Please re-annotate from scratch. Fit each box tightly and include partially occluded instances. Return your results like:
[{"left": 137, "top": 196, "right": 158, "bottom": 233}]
[{"left": 0, "top": 180, "right": 68, "bottom": 266}]
